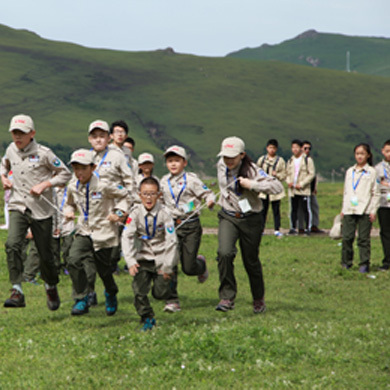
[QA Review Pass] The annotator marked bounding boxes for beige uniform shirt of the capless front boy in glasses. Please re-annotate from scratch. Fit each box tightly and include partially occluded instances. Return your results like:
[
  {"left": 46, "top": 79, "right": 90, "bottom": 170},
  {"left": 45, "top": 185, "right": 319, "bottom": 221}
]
[{"left": 122, "top": 203, "right": 178, "bottom": 274}]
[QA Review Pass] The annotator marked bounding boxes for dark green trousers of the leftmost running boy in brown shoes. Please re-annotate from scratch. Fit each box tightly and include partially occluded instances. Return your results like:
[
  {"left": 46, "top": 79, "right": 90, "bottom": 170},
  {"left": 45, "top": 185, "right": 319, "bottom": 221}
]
[{"left": 5, "top": 210, "right": 58, "bottom": 286}]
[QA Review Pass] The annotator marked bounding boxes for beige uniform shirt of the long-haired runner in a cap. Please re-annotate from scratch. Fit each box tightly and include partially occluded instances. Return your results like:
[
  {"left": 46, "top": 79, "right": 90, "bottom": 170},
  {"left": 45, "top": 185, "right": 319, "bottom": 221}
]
[{"left": 217, "top": 158, "right": 284, "bottom": 213}]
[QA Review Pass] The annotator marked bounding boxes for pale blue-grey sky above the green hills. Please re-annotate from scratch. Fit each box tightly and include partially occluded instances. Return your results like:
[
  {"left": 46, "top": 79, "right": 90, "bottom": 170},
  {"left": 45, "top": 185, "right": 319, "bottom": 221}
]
[{"left": 0, "top": 0, "right": 390, "bottom": 57}]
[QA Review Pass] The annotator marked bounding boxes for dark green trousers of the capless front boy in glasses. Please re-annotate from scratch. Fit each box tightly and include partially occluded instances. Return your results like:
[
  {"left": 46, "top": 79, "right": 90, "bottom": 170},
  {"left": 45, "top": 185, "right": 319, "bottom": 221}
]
[{"left": 132, "top": 260, "right": 171, "bottom": 320}]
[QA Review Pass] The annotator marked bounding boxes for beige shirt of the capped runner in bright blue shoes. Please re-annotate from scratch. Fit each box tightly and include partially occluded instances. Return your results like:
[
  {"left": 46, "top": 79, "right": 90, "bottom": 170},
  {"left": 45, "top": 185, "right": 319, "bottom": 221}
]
[{"left": 64, "top": 175, "right": 131, "bottom": 251}]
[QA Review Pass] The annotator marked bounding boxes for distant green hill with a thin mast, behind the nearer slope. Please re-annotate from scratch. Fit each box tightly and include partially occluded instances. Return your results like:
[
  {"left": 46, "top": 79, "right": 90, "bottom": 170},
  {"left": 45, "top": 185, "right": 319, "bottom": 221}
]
[{"left": 228, "top": 30, "right": 390, "bottom": 76}]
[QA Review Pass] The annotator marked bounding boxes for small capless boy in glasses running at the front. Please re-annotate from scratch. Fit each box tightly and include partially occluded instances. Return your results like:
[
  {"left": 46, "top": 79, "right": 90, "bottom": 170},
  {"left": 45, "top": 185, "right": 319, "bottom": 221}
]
[{"left": 122, "top": 177, "right": 177, "bottom": 331}]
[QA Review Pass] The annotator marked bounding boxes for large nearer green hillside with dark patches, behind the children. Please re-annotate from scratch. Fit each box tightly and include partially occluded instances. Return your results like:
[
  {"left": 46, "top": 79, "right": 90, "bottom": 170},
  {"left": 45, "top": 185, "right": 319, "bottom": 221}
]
[{"left": 0, "top": 25, "right": 390, "bottom": 175}]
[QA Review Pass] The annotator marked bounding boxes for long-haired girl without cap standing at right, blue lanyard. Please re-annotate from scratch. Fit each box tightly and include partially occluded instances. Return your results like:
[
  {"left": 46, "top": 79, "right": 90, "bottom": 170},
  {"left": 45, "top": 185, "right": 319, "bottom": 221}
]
[{"left": 341, "top": 143, "right": 380, "bottom": 273}]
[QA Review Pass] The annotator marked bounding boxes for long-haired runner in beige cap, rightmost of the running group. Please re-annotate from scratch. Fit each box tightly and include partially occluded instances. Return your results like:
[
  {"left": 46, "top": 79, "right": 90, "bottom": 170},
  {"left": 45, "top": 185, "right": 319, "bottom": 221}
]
[{"left": 216, "top": 137, "right": 283, "bottom": 313}]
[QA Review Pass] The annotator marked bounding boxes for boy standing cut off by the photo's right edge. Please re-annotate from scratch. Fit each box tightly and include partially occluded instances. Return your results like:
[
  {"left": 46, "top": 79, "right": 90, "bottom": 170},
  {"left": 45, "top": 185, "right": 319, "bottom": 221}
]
[{"left": 375, "top": 139, "right": 390, "bottom": 271}]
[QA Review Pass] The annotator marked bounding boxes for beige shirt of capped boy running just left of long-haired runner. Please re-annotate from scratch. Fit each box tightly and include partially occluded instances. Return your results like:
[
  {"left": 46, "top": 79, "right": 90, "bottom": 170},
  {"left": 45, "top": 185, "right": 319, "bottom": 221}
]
[{"left": 160, "top": 171, "right": 215, "bottom": 219}]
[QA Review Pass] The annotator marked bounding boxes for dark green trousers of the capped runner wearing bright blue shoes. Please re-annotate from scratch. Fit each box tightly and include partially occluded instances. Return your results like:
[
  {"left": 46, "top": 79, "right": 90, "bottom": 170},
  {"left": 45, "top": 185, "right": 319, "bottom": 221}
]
[{"left": 68, "top": 235, "right": 118, "bottom": 299}]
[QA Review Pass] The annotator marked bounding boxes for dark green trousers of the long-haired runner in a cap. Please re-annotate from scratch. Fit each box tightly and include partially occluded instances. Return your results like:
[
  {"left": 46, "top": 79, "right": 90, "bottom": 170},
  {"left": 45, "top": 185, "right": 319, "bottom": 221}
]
[{"left": 218, "top": 211, "right": 264, "bottom": 301}]
